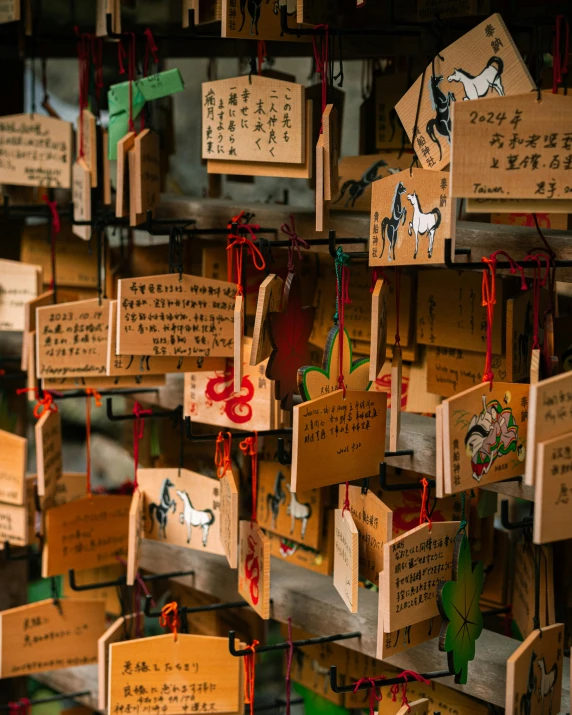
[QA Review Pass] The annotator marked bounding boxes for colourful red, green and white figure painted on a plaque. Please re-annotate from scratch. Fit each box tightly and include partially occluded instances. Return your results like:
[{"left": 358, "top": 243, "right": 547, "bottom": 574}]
[{"left": 464, "top": 392, "right": 524, "bottom": 482}]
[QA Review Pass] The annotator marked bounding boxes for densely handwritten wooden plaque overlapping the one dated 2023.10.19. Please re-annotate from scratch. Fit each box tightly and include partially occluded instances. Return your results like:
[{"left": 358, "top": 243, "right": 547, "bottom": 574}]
[{"left": 117, "top": 273, "right": 236, "bottom": 357}]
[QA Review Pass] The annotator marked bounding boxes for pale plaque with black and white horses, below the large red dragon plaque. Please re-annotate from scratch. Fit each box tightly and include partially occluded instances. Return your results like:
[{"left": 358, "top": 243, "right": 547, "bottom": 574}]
[{"left": 137, "top": 468, "right": 224, "bottom": 554}]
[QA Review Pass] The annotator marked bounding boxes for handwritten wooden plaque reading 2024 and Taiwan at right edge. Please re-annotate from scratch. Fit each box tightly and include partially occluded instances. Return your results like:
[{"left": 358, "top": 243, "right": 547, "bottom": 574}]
[{"left": 451, "top": 89, "right": 572, "bottom": 200}]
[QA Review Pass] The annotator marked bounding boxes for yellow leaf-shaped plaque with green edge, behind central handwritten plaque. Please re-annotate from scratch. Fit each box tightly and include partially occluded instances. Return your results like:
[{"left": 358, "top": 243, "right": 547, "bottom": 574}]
[{"left": 298, "top": 325, "right": 371, "bottom": 400}]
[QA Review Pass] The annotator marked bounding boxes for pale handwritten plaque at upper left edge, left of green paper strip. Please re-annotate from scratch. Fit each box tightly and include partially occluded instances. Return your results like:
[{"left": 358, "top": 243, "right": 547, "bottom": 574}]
[{"left": 0, "top": 114, "right": 72, "bottom": 189}]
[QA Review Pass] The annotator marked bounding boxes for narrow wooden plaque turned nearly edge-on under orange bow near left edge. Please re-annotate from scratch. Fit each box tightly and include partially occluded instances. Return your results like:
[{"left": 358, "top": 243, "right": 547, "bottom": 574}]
[{"left": 34, "top": 410, "right": 63, "bottom": 503}]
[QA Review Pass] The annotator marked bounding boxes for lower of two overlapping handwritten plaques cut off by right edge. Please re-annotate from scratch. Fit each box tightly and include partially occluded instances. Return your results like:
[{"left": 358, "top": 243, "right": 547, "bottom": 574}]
[{"left": 533, "top": 432, "right": 572, "bottom": 544}]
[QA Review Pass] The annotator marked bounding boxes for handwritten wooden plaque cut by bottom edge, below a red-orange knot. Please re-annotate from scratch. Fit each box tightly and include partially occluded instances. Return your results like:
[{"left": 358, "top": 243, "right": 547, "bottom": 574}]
[{"left": 108, "top": 633, "right": 242, "bottom": 715}]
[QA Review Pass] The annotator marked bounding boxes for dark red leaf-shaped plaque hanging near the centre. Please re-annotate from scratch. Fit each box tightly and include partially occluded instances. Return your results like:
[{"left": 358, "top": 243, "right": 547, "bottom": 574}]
[{"left": 266, "top": 273, "right": 316, "bottom": 410}]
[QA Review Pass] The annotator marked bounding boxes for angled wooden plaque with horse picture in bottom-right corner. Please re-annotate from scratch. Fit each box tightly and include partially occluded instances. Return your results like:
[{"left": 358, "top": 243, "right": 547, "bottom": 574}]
[{"left": 505, "top": 623, "right": 565, "bottom": 715}]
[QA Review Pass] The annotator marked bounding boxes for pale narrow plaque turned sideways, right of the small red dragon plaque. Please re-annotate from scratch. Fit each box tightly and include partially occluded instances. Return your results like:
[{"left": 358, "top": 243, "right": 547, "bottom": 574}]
[{"left": 334, "top": 509, "right": 359, "bottom": 613}]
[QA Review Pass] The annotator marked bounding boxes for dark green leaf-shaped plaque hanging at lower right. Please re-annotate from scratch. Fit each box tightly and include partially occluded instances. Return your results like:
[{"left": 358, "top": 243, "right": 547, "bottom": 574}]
[{"left": 437, "top": 534, "right": 484, "bottom": 684}]
